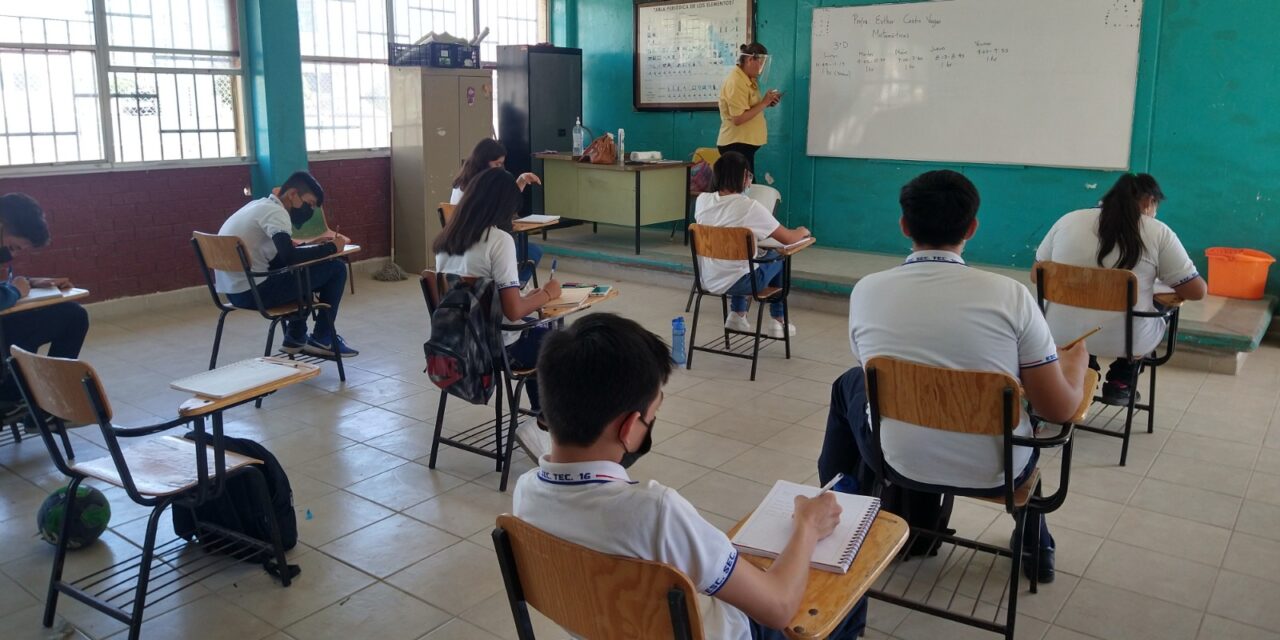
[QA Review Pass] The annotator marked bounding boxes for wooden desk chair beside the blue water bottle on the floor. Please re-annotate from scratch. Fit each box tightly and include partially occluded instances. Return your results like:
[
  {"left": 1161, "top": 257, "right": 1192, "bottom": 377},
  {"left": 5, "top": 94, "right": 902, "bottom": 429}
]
[{"left": 686, "top": 224, "right": 791, "bottom": 380}]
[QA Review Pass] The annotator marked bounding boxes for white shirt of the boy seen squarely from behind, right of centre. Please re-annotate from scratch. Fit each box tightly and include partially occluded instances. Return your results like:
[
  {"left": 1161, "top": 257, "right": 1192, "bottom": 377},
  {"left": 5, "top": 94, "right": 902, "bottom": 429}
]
[{"left": 849, "top": 251, "right": 1057, "bottom": 489}]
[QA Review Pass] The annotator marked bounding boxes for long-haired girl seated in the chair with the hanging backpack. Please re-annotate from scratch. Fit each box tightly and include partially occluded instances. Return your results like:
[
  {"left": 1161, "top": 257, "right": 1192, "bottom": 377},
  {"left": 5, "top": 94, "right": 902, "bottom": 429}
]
[{"left": 431, "top": 169, "right": 561, "bottom": 413}]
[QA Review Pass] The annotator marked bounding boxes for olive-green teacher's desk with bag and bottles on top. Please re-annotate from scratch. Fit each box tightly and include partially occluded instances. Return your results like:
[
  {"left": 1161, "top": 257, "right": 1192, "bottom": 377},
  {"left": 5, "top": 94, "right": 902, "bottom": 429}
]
[{"left": 534, "top": 154, "right": 691, "bottom": 253}]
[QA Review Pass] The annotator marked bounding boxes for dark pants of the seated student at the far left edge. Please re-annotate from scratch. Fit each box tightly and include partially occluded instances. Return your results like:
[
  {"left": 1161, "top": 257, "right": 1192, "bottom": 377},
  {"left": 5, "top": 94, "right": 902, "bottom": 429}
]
[{"left": 0, "top": 302, "right": 88, "bottom": 401}]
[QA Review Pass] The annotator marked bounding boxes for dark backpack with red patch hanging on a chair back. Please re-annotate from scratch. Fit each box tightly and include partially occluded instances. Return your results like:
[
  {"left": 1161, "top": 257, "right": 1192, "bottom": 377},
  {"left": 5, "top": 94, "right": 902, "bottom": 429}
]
[{"left": 422, "top": 275, "right": 503, "bottom": 404}]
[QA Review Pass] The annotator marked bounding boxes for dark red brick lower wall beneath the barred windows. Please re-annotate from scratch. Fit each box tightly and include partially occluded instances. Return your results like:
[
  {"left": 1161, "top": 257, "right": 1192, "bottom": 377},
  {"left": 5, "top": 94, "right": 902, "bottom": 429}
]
[{"left": 0, "top": 157, "right": 390, "bottom": 303}]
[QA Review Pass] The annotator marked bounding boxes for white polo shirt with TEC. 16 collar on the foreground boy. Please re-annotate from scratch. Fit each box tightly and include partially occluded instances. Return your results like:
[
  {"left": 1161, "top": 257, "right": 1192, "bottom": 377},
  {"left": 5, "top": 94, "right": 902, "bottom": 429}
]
[{"left": 512, "top": 456, "right": 751, "bottom": 640}]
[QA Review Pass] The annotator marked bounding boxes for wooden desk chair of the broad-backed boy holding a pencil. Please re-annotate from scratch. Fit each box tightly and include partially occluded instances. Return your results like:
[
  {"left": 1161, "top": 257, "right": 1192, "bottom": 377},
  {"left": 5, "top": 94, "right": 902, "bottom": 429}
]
[{"left": 865, "top": 357, "right": 1080, "bottom": 640}]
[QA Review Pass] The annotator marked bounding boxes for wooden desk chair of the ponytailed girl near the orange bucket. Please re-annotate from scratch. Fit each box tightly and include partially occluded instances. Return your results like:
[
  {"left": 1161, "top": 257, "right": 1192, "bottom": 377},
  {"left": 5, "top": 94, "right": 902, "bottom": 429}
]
[{"left": 1034, "top": 262, "right": 1179, "bottom": 467}]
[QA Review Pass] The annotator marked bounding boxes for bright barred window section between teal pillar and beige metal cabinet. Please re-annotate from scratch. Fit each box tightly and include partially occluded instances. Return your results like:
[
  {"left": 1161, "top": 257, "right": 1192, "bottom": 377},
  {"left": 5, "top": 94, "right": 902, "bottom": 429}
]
[{"left": 298, "top": 0, "right": 389, "bottom": 151}]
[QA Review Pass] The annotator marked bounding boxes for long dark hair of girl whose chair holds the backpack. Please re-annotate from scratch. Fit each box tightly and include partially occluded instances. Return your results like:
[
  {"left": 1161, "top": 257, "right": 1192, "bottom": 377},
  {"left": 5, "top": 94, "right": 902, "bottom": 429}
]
[{"left": 431, "top": 169, "right": 524, "bottom": 256}]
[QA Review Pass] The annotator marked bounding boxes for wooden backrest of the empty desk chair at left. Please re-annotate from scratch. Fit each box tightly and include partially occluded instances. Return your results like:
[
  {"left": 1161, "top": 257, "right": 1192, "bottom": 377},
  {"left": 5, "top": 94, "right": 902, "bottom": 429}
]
[{"left": 9, "top": 347, "right": 111, "bottom": 426}]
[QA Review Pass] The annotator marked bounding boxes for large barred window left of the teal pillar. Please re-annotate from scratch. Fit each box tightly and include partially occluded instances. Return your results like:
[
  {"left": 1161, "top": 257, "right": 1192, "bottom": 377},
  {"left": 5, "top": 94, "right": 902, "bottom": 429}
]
[{"left": 0, "top": 0, "right": 246, "bottom": 166}]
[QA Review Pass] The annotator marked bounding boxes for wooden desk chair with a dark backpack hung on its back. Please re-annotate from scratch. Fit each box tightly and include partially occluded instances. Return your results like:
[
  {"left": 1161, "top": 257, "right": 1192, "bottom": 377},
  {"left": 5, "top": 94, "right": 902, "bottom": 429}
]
[{"left": 421, "top": 269, "right": 538, "bottom": 492}]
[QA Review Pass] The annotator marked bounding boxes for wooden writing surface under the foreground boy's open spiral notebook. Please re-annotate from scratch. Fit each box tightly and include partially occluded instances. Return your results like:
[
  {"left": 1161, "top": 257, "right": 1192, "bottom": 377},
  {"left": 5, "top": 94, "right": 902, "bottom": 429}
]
[{"left": 728, "top": 509, "right": 910, "bottom": 640}]
